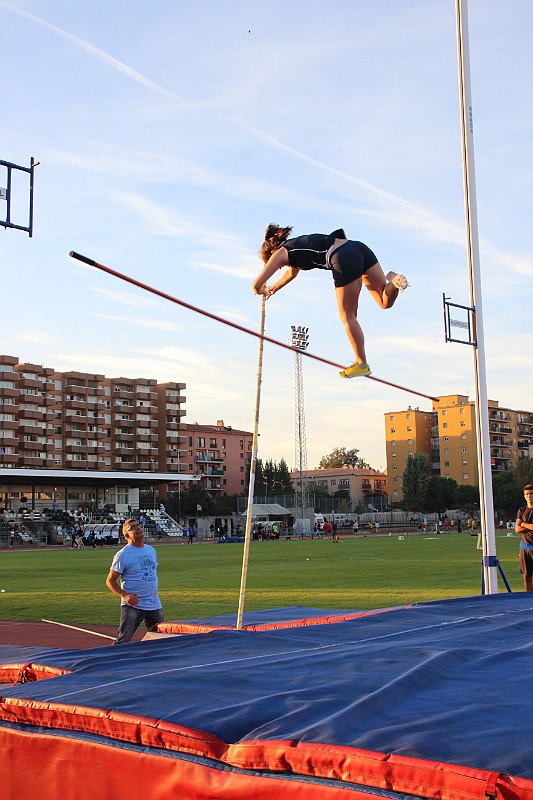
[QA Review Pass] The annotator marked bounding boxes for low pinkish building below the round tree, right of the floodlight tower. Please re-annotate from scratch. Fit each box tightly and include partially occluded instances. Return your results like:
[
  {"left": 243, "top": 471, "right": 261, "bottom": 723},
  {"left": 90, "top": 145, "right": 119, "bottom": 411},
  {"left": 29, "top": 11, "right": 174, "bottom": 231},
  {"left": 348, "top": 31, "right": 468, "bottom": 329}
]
[{"left": 291, "top": 467, "right": 387, "bottom": 505}]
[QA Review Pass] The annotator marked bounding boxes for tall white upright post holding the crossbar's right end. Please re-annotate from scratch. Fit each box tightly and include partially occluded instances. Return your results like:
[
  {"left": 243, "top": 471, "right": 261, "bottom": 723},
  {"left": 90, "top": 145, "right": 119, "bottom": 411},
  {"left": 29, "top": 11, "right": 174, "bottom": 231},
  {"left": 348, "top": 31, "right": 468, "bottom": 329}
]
[{"left": 455, "top": 0, "right": 498, "bottom": 594}]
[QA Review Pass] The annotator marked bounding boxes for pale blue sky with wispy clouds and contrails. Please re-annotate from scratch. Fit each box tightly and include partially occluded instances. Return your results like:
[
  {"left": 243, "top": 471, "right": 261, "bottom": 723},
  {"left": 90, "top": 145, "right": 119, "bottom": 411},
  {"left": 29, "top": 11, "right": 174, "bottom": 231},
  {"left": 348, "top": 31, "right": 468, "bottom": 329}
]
[{"left": 0, "top": 0, "right": 533, "bottom": 468}]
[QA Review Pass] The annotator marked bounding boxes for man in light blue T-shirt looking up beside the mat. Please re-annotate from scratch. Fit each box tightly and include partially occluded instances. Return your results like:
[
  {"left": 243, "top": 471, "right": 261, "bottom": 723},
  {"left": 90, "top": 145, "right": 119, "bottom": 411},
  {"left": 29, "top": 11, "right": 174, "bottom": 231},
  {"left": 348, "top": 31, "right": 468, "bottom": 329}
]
[{"left": 106, "top": 518, "right": 164, "bottom": 644}]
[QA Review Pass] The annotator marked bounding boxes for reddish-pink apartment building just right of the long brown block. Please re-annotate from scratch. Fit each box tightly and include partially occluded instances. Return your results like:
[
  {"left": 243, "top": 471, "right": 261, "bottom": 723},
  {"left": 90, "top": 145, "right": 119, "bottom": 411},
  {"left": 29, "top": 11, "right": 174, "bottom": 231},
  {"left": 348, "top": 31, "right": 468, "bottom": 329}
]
[{"left": 179, "top": 420, "right": 253, "bottom": 495}]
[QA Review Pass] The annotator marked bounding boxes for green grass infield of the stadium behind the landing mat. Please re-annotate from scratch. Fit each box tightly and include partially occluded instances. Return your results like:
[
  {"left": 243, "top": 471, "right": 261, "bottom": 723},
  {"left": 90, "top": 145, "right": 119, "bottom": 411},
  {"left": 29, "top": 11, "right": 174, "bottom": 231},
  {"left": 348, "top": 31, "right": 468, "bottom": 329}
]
[{"left": 0, "top": 534, "right": 522, "bottom": 625}]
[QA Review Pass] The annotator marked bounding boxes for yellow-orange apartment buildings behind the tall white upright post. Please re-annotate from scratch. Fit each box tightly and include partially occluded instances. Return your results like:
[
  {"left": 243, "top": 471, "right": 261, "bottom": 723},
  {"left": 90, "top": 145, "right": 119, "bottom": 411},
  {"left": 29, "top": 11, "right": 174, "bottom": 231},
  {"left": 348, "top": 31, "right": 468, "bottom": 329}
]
[{"left": 385, "top": 394, "right": 533, "bottom": 502}]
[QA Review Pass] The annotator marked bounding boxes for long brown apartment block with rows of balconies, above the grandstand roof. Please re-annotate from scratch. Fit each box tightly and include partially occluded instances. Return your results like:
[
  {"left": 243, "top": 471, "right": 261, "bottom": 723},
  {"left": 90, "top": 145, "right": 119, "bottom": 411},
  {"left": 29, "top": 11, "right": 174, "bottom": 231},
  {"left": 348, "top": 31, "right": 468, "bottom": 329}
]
[{"left": 0, "top": 355, "right": 185, "bottom": 472}]
